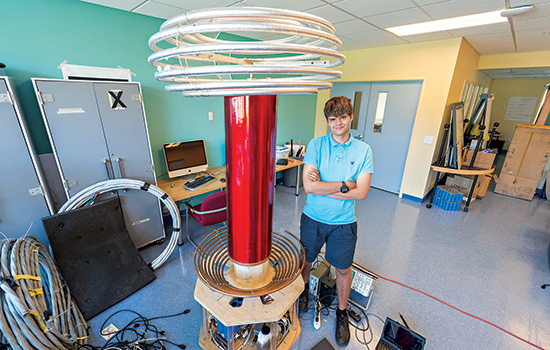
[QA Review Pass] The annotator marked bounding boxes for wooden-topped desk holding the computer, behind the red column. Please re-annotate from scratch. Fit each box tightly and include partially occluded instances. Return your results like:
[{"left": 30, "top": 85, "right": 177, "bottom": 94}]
[{"left": 157, "top": 158, "right": 303, "bottom": 202}]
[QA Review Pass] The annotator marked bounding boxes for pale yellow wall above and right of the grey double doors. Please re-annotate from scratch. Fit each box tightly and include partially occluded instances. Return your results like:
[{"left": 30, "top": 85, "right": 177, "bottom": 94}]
[{"left": 324, "top": 38, "right": 466, "bottom": 198}]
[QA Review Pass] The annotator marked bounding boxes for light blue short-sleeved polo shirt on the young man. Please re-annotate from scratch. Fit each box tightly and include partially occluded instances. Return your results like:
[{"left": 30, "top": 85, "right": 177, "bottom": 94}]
[{"left": 304, "top": 134, "right": 373, "bottom": 225}]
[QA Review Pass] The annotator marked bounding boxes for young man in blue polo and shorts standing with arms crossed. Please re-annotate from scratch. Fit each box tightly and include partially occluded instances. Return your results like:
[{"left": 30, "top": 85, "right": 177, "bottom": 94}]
[{"left": 300, "top": 96, "right": 373, "bottom": 346}]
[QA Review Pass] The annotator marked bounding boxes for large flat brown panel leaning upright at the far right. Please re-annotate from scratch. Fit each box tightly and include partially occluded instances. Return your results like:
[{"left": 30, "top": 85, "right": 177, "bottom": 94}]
[{"left": 495, "top": 125, "right": 550, "bottom": 201}]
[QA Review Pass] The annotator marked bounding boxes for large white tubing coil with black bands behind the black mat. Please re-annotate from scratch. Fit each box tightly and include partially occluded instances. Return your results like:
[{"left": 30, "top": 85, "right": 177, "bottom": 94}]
[{"left": 59, "top": 179, "right": 181, "bottom": 270}]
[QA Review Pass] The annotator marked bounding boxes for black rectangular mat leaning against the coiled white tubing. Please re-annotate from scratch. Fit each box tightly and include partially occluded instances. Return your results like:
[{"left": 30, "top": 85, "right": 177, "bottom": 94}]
[{"left": 42, "top": 198, "right": 155, "bottom": 320}]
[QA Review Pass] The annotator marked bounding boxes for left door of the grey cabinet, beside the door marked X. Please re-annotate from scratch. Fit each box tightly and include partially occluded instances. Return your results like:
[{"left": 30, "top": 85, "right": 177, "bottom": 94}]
[{"left": 33, "top": 79, "right": 112, "bottom": 198}]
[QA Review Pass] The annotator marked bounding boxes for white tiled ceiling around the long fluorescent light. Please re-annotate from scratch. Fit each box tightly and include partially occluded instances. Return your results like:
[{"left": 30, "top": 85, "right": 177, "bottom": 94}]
[{"left": 81, "top": 0, "right": 550, "bottom": 77}]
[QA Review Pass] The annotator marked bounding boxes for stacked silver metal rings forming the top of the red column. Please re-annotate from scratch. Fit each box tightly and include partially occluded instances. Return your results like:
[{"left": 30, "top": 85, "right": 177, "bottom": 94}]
[{"left": 148, "top": 7, "right": 346, "bottom": 96}]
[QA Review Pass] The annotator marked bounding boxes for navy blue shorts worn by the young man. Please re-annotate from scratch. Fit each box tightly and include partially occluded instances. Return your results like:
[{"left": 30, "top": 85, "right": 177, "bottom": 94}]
[{"left": 300, "top": 213, "right": 357, "bottom": 270}]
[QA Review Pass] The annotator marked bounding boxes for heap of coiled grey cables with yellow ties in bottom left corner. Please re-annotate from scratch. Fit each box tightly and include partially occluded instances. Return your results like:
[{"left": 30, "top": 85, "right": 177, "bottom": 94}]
[{"left": 0, "top": 235, "right": 88, "bottom": 350}]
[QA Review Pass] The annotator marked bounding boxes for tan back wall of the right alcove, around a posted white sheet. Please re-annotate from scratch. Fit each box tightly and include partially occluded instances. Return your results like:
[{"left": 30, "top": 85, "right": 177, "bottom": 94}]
[{"left": 490, "top": 78, "right": 550, "bottom": 149}]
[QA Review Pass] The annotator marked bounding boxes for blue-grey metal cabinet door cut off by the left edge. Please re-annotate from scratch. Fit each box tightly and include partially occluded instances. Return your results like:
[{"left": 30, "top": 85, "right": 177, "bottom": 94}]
[{"left": 0, "top": 78, "right": 50, "bottom": 244}]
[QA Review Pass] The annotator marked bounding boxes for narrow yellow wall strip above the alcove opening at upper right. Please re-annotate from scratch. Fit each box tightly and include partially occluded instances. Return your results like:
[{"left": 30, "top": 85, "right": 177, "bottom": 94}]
[{"left": 478, "top": 51, "right": 550, "bottom": 69}]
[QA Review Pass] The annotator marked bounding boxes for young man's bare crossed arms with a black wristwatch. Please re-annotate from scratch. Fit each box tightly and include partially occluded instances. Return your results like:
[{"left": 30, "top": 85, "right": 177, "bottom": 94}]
[{"left": 303, "top": 164, "right": 372, "bottom": 200}]
